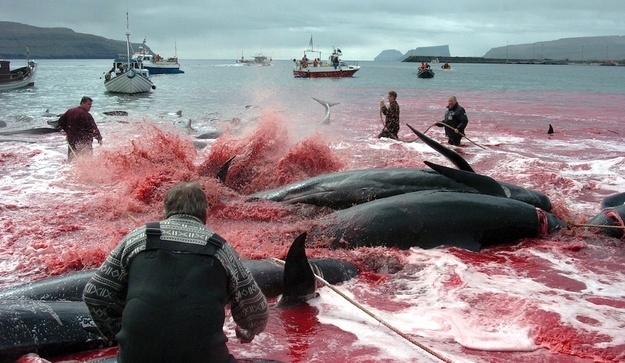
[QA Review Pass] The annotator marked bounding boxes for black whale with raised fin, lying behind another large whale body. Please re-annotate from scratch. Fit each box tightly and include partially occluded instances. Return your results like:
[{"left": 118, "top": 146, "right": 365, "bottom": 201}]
[{"left": 249, "top": 131, "right": 551, "bottom": 211}]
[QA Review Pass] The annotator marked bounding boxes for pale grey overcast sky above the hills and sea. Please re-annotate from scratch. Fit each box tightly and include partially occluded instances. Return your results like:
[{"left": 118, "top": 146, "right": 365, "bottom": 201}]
[{"left": 0, "top": 0, "right": 625, "bottom": 60}]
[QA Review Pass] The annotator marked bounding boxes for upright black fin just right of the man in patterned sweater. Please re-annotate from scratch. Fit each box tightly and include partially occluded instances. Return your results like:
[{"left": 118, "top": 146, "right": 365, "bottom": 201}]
[{"left": 277, "top": 232, "right": 318, "bottom": 308}]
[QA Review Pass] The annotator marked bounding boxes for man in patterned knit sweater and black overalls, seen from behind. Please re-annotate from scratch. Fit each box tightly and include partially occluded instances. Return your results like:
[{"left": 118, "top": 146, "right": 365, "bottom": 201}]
[{"left": 83, "top": 182, "right": 269, "bottom": 363}]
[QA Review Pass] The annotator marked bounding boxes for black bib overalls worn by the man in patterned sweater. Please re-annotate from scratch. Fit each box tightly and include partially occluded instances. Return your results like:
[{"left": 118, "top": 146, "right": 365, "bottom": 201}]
[{"left": 116, "top": 222, "right": 234, "bottom": 363}]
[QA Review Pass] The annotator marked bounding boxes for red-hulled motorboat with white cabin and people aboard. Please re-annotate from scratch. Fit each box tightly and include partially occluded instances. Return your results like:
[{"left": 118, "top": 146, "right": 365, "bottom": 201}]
[{"left": 293, "top": 36, "right": 360, "bottom": 78}]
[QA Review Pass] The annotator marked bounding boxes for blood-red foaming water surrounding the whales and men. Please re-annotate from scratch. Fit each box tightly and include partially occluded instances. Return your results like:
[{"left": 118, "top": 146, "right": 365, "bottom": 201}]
[{"left": 0, "top": 92, "right": 625, "bottom": 362}]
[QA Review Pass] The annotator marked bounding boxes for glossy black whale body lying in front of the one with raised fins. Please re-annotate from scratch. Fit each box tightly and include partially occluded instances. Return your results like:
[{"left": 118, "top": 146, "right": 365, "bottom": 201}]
[{"left": 310, "top": 190, "right": 566, "bottom": 251}]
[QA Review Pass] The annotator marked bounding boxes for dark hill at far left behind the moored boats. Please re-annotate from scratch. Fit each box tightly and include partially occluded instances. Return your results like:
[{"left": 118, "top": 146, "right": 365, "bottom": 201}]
[{"left": 0, "top": 21, "right": 151, "bottom": 59}]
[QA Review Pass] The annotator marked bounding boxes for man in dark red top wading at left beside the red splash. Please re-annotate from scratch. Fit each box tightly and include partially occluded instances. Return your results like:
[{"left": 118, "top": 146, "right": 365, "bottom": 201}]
[{"left": 58, "top": 96, "right": 102, "bottom": 161}]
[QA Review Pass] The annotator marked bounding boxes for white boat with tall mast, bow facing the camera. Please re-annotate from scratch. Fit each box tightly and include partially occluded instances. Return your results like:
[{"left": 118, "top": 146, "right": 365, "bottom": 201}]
[{"left": 104, "top": 13, "right": 156, "bottom": 94}]
